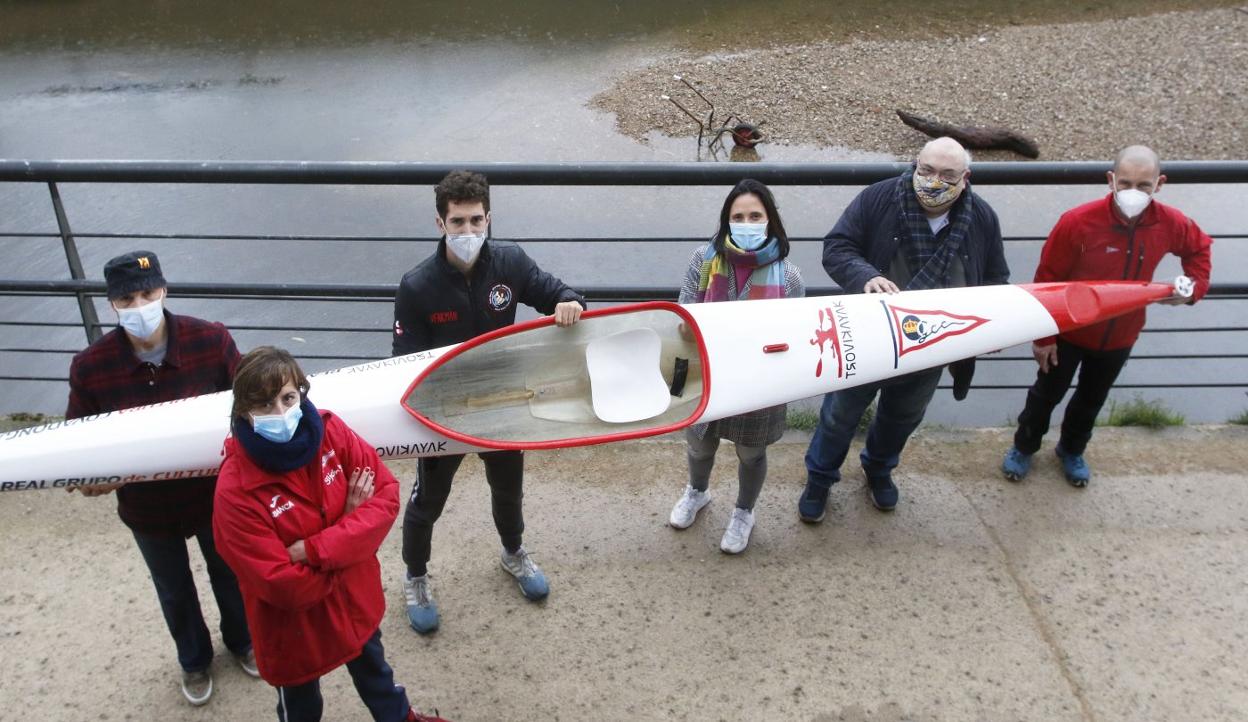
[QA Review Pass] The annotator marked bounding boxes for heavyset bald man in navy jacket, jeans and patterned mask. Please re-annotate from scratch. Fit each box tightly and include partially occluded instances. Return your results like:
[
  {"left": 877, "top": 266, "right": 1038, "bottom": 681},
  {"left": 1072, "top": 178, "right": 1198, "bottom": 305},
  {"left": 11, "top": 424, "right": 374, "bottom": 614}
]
[{"left": 797, "top": 137, "right": 1010, "bottom": 522}]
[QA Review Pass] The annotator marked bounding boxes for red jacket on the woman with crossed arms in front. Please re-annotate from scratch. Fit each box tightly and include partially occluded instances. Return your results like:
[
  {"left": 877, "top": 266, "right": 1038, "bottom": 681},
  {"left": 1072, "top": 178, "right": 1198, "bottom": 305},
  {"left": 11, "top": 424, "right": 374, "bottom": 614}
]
[{"left": 212, "top": 412, "right": 398, "bottom": 687}]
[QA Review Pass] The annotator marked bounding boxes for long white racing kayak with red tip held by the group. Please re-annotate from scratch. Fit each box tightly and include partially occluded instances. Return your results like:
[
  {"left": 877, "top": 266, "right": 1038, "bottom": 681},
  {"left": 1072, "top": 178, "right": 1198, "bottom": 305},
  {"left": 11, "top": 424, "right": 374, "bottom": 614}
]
[{"left": 0, "top": 282, "right": 1189, "bottom": 491}]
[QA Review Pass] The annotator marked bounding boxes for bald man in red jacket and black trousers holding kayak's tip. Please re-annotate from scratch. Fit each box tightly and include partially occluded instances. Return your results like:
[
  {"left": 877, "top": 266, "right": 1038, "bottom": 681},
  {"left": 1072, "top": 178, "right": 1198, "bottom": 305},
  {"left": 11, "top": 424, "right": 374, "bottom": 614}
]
[{"left": 1001, "top": 146, "right": 1213, "bottom": 486}]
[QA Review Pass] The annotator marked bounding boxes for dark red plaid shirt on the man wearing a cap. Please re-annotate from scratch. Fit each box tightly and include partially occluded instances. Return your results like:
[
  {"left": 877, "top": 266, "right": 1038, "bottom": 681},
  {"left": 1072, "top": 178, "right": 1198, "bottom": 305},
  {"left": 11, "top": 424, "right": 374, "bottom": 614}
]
[{"left": 65, "top": 310, "right": 238, "bottom": 537}]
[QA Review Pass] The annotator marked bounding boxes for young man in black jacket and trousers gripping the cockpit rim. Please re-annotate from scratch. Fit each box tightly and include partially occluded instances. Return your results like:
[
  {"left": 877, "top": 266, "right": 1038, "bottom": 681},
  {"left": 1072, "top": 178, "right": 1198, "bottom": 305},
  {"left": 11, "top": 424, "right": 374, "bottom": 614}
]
[{"left": 392, "top": 171, "right": 585, "bottom": 635}]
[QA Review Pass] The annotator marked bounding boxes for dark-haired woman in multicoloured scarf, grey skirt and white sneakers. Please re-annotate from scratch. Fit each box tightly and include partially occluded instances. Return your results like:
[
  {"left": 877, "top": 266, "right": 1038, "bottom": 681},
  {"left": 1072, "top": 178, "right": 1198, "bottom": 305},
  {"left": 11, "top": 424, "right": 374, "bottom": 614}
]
[{"left": 669, "top": 178, "right": 805, "bottom": 554}]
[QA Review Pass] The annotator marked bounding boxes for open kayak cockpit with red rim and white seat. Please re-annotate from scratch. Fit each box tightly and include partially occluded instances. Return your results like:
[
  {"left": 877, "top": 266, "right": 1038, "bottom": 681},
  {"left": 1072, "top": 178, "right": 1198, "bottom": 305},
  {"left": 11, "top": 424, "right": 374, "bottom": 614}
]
[{"left": 403, "top": 303, "right": 708, "bottom": 449}]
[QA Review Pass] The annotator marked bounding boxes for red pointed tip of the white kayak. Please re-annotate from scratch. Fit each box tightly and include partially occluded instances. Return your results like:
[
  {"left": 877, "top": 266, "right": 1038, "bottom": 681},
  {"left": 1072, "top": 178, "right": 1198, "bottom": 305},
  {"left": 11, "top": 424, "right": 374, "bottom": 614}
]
[{"left": 1020, "top": 281, "right": 1174, "bottom": 333}]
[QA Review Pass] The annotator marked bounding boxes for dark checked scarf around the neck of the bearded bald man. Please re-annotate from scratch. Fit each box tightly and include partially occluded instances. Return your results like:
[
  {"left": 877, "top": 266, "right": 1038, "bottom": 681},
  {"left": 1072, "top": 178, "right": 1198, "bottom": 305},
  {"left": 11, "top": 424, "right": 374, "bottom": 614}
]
[{"left": 897, "top": 171, "right": 971, "bottom": 291}]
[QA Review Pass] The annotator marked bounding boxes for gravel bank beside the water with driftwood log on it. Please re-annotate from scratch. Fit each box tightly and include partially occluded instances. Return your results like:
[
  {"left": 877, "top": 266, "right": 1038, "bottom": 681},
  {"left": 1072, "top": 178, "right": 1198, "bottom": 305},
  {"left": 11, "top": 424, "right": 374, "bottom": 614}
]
[{"left": 590, "top": 9, "right": 1248, "bottom": 160}]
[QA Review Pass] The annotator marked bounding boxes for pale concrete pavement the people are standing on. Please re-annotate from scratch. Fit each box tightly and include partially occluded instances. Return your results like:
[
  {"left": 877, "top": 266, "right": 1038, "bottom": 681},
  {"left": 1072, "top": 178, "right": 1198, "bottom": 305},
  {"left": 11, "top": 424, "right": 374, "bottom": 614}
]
[{"left": 0, "top": 426, "right": 1248, "bottom": 722}]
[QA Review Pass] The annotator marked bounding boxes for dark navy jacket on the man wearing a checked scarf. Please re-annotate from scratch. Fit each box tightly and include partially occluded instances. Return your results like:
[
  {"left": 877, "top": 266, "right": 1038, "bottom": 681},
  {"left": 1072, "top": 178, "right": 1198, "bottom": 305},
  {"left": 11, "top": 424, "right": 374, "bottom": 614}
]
[{"left": 824, "top": 177, "right": 1010, "bottom": 293}]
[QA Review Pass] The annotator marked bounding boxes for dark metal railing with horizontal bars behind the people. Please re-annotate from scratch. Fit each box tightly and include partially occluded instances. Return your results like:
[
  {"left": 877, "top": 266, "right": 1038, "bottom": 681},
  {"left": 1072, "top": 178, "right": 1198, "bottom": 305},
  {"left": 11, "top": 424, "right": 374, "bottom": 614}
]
[{"left": 0, "top": 160, "right": 1248, "bottom": 389}]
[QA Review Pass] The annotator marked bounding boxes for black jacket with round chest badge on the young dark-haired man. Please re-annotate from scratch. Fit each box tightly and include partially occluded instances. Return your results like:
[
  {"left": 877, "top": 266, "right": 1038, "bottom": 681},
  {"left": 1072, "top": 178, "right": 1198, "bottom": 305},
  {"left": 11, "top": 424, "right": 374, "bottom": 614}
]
[{"left": 391, "top": 239, "right": 585, "bottom": 355}]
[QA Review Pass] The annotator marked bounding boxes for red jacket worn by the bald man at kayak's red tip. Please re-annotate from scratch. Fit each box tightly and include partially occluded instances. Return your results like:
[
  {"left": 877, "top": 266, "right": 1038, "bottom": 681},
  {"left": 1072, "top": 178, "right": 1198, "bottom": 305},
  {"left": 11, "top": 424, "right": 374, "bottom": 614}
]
[{"left": 1036, "top": 193, "right": 1213, "bottom": 350}]
